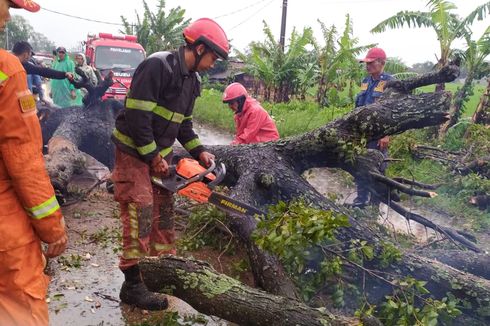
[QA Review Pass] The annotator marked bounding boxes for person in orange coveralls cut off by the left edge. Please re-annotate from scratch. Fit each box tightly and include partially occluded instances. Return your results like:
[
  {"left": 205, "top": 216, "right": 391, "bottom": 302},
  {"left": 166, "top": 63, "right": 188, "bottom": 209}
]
[{"left": 0, "top": 0, "right": 67, "bottom": 326}]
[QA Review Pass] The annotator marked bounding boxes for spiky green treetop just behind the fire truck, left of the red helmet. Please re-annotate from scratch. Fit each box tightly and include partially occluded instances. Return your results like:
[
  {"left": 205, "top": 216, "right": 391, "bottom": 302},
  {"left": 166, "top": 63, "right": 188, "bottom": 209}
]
[{"left": 121, "top": 0, "right": 190, "bottom": 54}]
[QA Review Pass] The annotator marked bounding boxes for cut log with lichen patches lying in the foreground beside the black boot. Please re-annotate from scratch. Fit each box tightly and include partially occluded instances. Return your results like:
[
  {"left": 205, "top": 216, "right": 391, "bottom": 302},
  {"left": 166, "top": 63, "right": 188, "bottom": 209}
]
[{"left": 140, "top": 256, "right": 366, "bottom": 326}]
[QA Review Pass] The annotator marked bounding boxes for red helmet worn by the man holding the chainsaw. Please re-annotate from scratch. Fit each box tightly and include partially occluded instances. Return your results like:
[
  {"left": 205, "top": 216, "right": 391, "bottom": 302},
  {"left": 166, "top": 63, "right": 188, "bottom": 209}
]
[{"left": 184, "top": 18, "right": 230, "bottom": 60}]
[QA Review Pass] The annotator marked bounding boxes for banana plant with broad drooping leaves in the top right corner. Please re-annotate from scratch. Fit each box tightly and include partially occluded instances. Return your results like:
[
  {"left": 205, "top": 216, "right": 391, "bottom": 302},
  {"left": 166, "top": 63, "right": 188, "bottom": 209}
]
[{"left": 371, "top": 0, "right": 490, "bottom": 90}]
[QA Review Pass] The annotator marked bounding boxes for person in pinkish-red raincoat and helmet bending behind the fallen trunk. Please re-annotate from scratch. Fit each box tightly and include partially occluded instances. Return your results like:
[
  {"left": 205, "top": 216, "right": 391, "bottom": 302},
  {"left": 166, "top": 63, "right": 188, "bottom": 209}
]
[{"left": 223, "top": 83, "right": 279, "bottom": 145}]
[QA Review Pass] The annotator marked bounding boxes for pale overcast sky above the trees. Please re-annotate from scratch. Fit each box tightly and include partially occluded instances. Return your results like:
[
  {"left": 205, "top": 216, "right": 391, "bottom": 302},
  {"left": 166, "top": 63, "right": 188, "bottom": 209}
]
[{"left": 15, "top": 0, "right": 490, "bottom": 65}]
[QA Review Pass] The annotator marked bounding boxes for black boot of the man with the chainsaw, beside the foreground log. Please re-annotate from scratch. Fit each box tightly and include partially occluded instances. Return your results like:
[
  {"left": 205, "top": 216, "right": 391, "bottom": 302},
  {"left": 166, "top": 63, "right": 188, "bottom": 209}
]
[{"left": 119, "top": 265, "right": 168, "bottom": 310}]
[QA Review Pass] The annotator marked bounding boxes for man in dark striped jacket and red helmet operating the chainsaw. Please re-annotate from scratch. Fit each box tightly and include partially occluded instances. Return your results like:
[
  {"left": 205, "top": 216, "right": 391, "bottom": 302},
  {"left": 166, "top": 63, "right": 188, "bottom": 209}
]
[{"left": 112, "top": 18, "right": 229, "bottom": 310}]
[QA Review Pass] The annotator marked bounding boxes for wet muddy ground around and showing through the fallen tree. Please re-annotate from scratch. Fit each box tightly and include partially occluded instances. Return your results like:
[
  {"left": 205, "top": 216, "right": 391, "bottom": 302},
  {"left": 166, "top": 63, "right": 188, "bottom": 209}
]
[{"left": 48, "top": 122, "right": 490, "bottom": 326}]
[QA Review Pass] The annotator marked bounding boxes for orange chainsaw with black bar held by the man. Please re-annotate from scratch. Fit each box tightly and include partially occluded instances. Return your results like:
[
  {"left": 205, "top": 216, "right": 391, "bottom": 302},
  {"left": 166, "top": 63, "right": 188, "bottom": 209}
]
[{"left": 151, "top": 158, "right": 265, "bottom": 216}]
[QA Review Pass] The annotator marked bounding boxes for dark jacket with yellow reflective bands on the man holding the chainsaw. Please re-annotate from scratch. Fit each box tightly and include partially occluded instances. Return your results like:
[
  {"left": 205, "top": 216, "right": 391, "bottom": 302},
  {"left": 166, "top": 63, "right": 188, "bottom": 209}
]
[{"left": 112, "top": 47, "right": 204, "bottom": 163}]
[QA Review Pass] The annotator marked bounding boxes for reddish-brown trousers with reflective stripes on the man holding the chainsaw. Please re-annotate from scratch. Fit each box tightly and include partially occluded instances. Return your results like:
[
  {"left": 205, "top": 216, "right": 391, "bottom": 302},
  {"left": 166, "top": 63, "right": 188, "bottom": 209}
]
[{"left": 112, "top": 149, "right": 175, "bottom": 270}]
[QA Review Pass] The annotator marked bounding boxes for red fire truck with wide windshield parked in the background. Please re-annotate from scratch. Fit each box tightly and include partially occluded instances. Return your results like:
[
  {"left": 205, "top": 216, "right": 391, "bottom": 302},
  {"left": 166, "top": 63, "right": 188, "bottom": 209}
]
[{"left": 85, "top": 33, "right": 146, "bottom": 99}]
